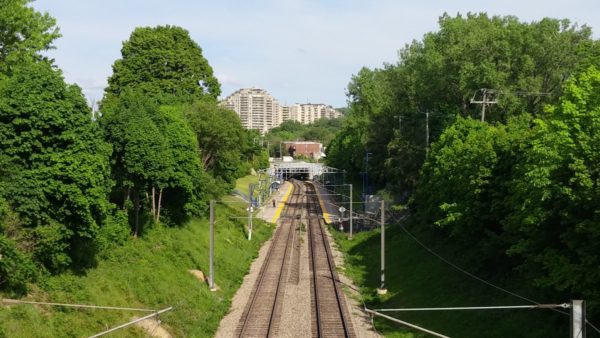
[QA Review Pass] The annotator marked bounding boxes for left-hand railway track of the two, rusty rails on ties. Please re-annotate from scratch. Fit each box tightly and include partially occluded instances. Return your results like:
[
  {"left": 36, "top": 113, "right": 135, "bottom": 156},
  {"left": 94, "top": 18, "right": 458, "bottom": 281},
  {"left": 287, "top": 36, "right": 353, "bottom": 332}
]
[{"left": 236, "top": 182, "right": 302, "bottom": 337}]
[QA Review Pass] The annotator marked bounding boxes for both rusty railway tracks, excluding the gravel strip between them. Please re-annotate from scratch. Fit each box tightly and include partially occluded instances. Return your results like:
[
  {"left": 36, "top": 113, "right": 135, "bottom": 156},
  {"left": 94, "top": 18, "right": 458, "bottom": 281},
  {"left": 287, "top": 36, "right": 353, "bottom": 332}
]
[{"left": 235, "top": 181, "right": 356, "bottom": 337}]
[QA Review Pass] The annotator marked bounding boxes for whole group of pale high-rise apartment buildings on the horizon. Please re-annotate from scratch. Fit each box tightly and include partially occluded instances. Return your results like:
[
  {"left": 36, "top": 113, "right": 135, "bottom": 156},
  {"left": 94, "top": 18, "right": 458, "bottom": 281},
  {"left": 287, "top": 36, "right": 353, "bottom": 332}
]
[{"left": 221, "top": 88, "right": 342, "bottom": 134}]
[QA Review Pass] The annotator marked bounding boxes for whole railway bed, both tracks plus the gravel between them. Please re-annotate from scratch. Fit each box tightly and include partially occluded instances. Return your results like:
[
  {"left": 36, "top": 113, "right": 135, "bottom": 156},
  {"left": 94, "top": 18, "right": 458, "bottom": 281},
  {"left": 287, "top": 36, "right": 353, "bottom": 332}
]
[{"left": 235, "top": 181, "right": 356, "bottom": 337}]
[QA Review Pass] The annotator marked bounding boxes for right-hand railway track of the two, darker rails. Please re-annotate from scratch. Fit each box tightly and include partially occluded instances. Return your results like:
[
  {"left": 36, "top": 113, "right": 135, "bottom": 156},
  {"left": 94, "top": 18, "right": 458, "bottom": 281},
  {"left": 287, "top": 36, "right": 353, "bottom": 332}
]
[{"left": 306, "top": 184, "right": 356, "bottom": 337}]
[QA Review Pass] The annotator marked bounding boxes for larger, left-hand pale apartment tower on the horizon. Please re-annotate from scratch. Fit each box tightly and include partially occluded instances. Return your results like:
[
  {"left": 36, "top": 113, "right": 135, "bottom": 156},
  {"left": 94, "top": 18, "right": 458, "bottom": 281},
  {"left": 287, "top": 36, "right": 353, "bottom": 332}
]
[{"left": 221, "top": 88, "right": 282, "bottom": 134}]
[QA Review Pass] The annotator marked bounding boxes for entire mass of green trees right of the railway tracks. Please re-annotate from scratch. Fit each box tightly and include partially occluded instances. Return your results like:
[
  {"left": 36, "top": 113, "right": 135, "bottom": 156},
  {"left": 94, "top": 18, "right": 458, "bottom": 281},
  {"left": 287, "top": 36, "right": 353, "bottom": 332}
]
[{"left": 327, "top": 14, "right": 600, "bottom": 313}]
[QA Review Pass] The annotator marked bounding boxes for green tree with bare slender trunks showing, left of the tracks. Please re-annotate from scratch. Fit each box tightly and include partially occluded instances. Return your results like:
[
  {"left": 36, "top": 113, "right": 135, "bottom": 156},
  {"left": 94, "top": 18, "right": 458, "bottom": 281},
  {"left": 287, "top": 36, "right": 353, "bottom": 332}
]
[{"left": 100, "top": 89, "right": 206, "bottom": 236}]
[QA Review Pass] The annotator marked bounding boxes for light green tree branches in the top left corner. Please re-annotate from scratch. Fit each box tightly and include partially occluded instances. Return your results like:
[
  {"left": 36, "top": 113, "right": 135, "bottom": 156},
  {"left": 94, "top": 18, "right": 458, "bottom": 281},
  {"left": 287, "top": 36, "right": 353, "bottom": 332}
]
[{"left": 0, "top": 0, "right": 60, "bottom": 73}]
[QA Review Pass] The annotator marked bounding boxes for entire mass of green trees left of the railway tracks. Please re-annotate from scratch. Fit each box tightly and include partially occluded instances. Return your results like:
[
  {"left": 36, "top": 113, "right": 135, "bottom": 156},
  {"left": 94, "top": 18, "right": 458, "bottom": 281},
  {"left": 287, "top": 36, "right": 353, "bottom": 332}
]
[{"left": 0, "top": 0, "right": 267, "bottom": 292}]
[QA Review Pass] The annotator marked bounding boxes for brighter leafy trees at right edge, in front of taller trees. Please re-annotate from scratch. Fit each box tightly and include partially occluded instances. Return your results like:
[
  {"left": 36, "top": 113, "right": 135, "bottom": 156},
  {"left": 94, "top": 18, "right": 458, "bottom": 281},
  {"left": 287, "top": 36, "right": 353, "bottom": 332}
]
[{"left": 413, "top": 67, "right": 600, "bottom": 309}]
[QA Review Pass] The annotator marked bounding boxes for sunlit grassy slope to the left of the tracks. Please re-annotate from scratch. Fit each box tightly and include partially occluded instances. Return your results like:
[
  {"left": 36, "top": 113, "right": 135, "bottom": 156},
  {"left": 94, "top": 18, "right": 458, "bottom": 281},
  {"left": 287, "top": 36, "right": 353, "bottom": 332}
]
[{"left": 0, "top": 176, "right": 273, "bottom": 338}]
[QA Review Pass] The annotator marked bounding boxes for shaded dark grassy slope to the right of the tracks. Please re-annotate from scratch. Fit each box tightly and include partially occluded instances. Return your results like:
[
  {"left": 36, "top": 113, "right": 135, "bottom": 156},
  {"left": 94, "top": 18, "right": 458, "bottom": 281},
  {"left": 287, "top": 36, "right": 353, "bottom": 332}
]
[{"left": 332, "top": 225, "right": 580, "bottom": 338}]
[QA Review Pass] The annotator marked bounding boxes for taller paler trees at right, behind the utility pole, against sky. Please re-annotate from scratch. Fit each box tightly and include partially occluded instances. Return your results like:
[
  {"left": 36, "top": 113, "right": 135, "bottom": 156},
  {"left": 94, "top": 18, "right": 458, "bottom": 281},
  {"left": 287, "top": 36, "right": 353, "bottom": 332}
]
[{"left": 327, "top": 14, "right": 600, "bottom": 195}]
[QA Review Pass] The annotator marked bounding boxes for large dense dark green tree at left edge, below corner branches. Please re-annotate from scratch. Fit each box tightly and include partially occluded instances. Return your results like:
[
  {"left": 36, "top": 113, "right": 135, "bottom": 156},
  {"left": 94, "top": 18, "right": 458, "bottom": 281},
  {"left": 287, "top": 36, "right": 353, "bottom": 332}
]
[{"left": 0, "top": 61, "right": 111, "bottom": 270}]
